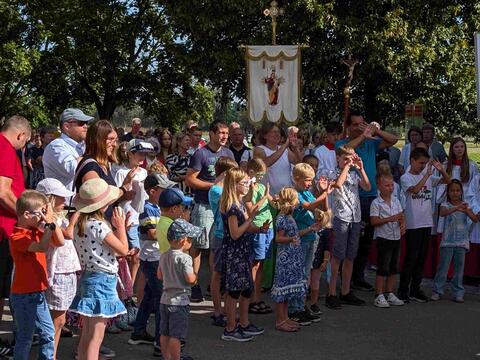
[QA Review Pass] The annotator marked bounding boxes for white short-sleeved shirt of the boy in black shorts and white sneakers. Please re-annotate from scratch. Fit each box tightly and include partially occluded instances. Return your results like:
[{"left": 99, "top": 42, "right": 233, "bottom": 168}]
[{"left": 370, "top": 196, "right": 403, "bottom": 240}]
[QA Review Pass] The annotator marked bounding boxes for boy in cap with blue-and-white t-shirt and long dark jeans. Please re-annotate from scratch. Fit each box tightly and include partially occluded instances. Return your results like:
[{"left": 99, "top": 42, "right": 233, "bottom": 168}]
[{"left": 128, "top": 173, "right": 176, "bottom": 355}]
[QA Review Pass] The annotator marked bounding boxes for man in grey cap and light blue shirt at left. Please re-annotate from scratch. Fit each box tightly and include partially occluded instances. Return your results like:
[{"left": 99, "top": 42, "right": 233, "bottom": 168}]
[{"left": 42, "top": 108, "right": 93, "bottom": 190}]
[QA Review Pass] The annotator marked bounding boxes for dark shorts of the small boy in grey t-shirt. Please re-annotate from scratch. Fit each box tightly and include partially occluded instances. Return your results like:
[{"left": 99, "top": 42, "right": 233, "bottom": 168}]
[{"left": 160, "top": 304, "right": 190, "bottom": 341}]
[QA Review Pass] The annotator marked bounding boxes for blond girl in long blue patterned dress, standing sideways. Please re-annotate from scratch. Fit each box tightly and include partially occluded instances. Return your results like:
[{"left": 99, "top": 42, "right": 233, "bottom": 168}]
[{"left": 271, "top": 187, "right": 307, "bottom": 332}]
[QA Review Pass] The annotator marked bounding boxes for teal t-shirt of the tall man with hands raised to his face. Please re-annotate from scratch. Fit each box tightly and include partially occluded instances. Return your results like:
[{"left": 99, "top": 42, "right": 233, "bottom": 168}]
[{"left": 335, "top": 139, "right": 382, "bottom": 197}]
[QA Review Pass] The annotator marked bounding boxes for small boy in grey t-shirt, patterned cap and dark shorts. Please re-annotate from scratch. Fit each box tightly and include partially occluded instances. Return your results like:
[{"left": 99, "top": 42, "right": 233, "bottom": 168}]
[{"left": 157, "top": 218, "right": 203, "bottom": 360}]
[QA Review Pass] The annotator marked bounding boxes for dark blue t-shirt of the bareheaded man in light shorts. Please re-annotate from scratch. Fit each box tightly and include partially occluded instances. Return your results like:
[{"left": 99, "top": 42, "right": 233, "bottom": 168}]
[{"left": 188, "top": 145, "right": 235, "bottom": 205}]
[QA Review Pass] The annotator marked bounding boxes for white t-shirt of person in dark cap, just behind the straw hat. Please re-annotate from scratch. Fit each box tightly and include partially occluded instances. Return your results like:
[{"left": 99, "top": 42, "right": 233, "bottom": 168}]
[{"left": 112, "top": 165, "right": 148, "bottom": 225}]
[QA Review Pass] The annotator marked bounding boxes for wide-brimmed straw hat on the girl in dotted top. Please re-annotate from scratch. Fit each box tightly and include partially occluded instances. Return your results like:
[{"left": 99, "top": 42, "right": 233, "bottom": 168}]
[{"left": 73, "top": 178, "right": 122, "bottom": 213}]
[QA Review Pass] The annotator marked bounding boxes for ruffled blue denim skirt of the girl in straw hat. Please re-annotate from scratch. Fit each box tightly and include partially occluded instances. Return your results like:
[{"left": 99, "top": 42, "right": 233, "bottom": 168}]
[{"left": 70, "top": 271, "right": 127, "bottom": 318}]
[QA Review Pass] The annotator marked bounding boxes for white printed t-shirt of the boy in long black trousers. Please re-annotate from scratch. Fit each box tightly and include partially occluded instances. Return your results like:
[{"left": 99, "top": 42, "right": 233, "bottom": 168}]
[{"left": 400, "top": 171, "right": 440, "bottom": 229}]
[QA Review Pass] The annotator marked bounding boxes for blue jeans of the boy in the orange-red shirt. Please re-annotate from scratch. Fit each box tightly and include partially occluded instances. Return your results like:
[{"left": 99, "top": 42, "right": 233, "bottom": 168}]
[{"left": 10, "top": 292, "right": 55, "bottom": 360}]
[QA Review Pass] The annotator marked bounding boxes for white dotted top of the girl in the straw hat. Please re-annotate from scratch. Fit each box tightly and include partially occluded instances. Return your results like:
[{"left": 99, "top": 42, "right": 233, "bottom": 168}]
[{"left": 74, "top": 219, "right": 118, "bottom": 274}]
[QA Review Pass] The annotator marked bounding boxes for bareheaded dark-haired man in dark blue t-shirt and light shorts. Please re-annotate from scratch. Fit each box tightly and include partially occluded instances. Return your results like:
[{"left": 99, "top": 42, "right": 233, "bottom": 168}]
[{"left": 185, "top": 121, "right": 235, "bottom": 302}]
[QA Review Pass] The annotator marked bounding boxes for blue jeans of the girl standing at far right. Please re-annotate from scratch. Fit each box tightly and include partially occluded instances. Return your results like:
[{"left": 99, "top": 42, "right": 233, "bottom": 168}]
[{"left": 433, "top": 246, "right": 467, "bottom": 298}]
